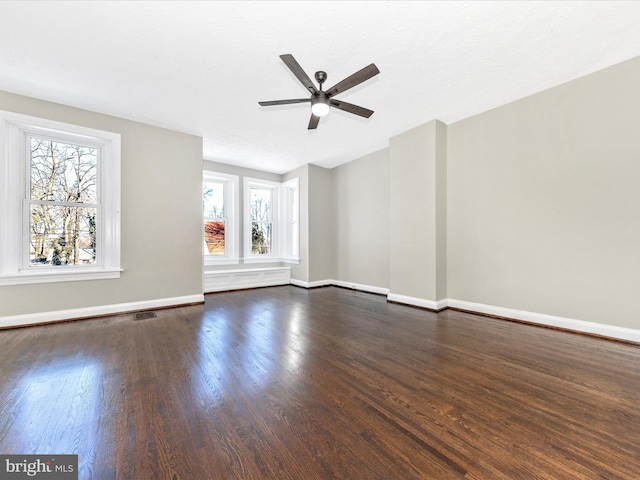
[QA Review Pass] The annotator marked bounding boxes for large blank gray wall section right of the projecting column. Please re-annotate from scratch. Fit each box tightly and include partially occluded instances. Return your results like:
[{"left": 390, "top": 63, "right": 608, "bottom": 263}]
[{"left": 448, "top": 54, "right": 640, "bottom": 329}]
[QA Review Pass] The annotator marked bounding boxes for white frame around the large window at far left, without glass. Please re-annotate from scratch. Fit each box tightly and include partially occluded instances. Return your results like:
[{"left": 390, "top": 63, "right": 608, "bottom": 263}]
[{"left": 0, "top": 110, "right": 122, "bottom": 285}]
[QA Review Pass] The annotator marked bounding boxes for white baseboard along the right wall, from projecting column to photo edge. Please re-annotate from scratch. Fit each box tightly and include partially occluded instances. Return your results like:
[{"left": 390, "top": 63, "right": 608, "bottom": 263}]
[{"left": 447, "top": 299, "right": 640, "bottom": 343}]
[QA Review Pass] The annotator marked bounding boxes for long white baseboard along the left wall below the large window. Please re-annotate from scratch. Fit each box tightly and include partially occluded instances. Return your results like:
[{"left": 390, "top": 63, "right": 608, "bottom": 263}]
[{"left": 0, "top": 294, "right": 204, "bottom": 327}]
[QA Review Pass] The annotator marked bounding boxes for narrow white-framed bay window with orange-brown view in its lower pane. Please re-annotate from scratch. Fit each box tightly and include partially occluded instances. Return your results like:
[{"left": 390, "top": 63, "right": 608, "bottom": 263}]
[{"left": 202, "top": 172, "right": 240, "bottom": 265}]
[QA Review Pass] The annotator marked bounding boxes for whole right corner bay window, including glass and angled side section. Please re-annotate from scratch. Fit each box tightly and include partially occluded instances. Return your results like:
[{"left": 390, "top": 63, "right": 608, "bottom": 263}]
[{"left": 244, "top": 178, "right": 299, "bottom": 263}]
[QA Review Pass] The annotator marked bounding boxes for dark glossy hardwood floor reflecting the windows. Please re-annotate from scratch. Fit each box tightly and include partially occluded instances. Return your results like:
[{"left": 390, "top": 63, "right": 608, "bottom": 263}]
[{"left": 0, "top": 286, "right": 640, "bottom": 480}]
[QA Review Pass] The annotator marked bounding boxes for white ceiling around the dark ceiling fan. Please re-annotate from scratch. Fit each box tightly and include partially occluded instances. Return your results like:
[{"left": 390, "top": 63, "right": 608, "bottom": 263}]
[{"left": 0, "top": 1, "right": 640, "bottom": 173}]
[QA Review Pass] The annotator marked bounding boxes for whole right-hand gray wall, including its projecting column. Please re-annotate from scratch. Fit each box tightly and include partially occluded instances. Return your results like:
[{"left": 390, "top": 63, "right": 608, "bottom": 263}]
[{"left": 324, "top": 58, "right": 640, "bottom": 329}]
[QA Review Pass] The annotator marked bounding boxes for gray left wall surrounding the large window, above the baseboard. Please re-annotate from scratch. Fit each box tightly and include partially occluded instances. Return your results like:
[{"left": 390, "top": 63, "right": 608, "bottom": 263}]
[{"left": 0, "top": 92, "right": 202, "bottom": 316}]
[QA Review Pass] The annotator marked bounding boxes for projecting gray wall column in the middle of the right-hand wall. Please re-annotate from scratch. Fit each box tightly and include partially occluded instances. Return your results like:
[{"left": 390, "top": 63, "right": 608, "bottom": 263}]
[{"left": 389, "top": 120, "right": 447, "bottom": 302}]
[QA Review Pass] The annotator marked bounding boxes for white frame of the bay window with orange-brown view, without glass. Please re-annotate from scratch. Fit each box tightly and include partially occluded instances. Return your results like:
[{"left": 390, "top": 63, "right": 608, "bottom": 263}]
[{"left": 202, "top": 170, "right": 240, "bottom": 265}]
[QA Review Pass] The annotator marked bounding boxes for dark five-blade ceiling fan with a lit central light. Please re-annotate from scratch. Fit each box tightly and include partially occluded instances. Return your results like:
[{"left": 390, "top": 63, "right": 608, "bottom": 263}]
[{"left": 258, "top": 54, "right": 380, "bottom": 130}]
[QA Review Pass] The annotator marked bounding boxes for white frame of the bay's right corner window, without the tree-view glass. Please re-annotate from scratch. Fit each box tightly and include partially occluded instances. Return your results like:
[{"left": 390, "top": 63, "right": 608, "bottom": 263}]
[{"left": 243, "top": 177, "right": 300, "bottom": 264}]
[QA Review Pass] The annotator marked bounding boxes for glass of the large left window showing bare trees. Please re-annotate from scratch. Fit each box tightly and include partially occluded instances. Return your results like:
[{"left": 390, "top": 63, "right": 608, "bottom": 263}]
[{"left": 29, "top": 137, "right": 98, "bottom": 265}]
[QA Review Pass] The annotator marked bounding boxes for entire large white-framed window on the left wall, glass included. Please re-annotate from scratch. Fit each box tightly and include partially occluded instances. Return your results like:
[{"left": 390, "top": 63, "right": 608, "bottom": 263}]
[{"left": 0, "top": 112, "right": 120, "bottom": 285}]
